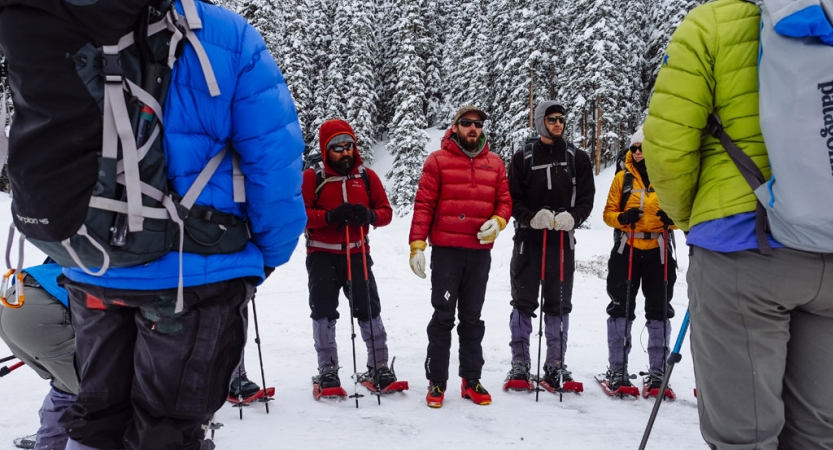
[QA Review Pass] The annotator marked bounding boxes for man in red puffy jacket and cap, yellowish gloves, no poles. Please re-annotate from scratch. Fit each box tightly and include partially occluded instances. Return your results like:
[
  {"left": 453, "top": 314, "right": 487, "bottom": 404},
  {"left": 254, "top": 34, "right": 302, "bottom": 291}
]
[{"left": 408, "top": 106, "right": 512, "bottom": 408}]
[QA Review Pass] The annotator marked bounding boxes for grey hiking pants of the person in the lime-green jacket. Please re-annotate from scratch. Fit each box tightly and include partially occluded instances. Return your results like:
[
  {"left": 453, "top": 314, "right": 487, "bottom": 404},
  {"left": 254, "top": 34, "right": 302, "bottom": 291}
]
[{"left": 688, "top": 247, "right": 833, "bottom": 450}]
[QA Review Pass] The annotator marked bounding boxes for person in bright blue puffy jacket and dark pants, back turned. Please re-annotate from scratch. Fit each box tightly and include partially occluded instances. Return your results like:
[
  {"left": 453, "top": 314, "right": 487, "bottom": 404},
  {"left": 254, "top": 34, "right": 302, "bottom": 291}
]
[{"left": 0, "top": 0, "right": 306, "bottom": 450}]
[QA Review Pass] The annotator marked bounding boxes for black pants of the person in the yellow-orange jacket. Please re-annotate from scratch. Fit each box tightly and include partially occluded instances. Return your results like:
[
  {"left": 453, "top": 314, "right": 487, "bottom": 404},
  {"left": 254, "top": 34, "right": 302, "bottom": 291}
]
[{"left": 607, "top": 244, "right": 677, "bottom": 321}]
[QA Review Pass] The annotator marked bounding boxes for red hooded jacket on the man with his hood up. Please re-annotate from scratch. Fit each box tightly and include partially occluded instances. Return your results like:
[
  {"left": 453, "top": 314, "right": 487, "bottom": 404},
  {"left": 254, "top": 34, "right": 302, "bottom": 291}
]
[{"left": 301, "top": 120, "right": 393, "bottom": 254}]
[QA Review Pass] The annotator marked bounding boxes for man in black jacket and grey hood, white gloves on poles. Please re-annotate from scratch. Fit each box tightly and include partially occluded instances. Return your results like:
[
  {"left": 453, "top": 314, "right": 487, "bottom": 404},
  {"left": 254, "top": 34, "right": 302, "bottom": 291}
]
[{"left": 506, "top": 101, "right": 596, "bottom": 390}]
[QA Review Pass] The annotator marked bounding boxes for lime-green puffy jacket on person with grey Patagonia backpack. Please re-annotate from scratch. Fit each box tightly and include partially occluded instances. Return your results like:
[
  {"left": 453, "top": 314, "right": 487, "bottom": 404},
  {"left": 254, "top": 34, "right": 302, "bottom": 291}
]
[{"left": 642, "top": 0, "right": 768, "bottom": 230}]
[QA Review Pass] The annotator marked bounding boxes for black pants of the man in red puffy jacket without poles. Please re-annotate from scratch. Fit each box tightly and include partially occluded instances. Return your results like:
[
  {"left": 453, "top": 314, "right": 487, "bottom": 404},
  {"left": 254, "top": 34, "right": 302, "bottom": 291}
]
[{"left": 425, "top": 247, "right": 492, "bottom": 382}]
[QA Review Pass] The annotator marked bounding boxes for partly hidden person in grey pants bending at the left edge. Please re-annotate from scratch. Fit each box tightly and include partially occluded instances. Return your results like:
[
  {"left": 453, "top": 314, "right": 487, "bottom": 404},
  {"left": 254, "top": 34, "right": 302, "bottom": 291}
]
[{"left": 0, "top": 263, "right": 78, "bottom": 450}]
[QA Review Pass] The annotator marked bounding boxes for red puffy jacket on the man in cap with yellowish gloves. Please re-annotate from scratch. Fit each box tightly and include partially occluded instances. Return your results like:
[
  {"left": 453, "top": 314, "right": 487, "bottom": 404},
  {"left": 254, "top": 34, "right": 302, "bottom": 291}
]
[{"left": 408, "top": 128, "right": 512, "bottom": 250}]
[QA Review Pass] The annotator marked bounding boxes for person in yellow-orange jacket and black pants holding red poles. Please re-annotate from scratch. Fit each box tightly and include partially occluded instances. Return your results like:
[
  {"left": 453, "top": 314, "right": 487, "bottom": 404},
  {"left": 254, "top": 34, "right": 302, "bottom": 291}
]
[{"left": 604, "top": 127, "right": 677, "bottom": 391}]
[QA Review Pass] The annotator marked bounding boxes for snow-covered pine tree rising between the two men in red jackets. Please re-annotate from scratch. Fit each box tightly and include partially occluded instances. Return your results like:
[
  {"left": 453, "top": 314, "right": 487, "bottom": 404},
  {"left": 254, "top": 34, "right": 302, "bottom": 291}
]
[{"left": 386, "top": 0, "right": 428, "bottom": 216}]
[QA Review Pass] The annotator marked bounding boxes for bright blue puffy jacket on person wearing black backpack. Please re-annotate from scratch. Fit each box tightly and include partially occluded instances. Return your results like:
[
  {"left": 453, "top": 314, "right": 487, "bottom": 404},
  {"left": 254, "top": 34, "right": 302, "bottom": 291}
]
[{"left": 64, "top": 1, "right": 306, "bottom": 290}]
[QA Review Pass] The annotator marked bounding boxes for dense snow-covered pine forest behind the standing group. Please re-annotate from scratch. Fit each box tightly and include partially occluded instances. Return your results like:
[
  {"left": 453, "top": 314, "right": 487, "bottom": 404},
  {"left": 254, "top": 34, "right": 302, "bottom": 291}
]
[{"left": 0, "top": 0, "right": 705, "bottom": 207}]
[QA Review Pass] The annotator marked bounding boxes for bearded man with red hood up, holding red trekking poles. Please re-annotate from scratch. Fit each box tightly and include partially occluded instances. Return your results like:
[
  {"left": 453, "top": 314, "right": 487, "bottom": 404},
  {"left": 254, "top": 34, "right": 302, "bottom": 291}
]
[{"left": 302, "top": 119, "right": 396, "bottom": 389}]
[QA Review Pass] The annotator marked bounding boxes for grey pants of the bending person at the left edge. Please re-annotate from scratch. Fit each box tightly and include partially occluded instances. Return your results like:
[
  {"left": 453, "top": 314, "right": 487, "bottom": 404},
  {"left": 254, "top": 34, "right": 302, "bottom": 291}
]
[{"left": 0, "top": 284, "right": 78, "bottom": 394}]
